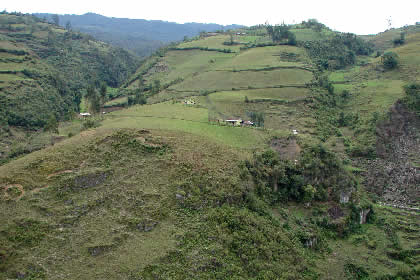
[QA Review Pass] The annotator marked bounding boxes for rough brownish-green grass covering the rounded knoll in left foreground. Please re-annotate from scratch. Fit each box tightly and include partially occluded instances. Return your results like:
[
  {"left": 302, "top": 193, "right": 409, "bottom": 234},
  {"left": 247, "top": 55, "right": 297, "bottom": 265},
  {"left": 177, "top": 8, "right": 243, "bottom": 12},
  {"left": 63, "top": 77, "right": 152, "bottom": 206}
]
[{"left": 0, "top": 128, "right": 249, "bottom": 279}]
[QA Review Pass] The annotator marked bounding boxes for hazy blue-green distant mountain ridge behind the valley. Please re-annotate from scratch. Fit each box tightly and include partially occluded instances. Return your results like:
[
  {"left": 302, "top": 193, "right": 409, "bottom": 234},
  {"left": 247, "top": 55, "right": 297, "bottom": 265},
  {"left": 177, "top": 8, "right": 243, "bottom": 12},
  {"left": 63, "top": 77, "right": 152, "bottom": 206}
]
[{"left": 34, "top": 13, "right": 243, "bottom": 56}]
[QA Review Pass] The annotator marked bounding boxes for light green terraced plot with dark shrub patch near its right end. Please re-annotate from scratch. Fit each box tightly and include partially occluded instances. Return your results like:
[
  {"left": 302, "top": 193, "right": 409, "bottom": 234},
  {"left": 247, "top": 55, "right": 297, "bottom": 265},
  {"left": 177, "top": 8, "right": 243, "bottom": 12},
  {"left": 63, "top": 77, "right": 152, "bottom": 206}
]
[{"left": 216, "top": 46, "right": 310, "bottom": 70}]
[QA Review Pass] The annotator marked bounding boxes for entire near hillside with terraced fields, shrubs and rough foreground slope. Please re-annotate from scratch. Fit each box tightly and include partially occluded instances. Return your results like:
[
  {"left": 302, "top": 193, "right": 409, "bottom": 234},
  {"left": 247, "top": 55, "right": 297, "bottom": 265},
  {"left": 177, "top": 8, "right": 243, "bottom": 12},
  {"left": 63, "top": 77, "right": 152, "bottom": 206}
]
[{"left": 0, "top": 15, "right": 420, "bottom": 280}]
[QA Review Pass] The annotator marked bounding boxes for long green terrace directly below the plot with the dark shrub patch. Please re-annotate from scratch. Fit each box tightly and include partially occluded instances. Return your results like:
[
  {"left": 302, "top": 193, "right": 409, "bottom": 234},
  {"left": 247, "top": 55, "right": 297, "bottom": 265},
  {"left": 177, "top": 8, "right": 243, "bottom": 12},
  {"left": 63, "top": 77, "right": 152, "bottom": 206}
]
[{"left": 170, "top": 69, "right": 312, "bottom": 91}]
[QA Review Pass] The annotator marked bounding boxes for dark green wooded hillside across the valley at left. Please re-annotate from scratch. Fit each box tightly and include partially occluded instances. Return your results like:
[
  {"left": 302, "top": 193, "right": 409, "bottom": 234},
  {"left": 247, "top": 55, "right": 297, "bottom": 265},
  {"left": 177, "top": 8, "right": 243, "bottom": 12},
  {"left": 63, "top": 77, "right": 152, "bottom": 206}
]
[{"left": 0, "top": 13, "right": 139, "bottom": 164}]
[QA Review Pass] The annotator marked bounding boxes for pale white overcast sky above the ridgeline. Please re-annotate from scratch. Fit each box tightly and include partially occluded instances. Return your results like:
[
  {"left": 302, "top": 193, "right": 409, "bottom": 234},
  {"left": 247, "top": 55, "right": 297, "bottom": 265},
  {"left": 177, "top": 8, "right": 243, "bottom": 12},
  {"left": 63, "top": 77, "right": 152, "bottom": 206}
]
[{"left": 0, "top": 0, "right": 420, "bottom": 35}]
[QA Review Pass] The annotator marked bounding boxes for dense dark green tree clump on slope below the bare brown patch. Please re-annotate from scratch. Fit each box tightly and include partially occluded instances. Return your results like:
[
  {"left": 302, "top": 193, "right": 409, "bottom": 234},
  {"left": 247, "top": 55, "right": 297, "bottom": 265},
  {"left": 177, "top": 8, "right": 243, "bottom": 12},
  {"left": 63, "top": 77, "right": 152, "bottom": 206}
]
[{"left": 244, "top": 145, "right": 357, "bottom": 203}]
